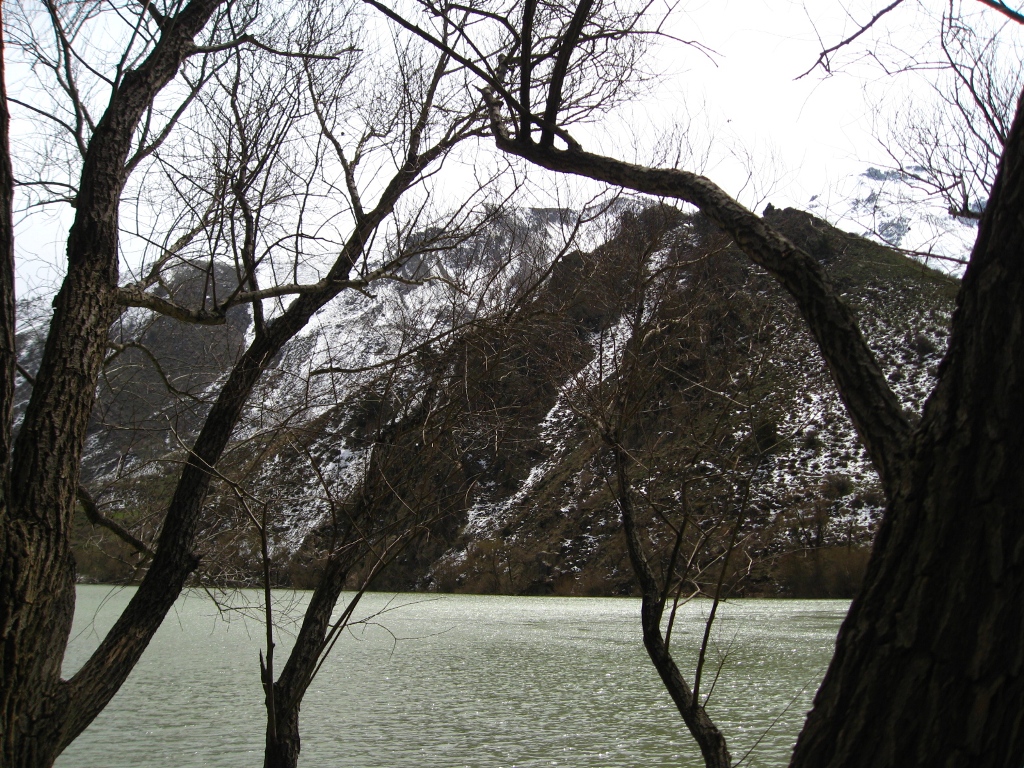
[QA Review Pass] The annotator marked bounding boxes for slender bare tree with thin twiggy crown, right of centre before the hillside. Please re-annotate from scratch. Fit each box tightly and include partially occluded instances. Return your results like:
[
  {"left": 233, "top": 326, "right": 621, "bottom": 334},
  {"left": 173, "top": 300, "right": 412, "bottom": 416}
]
[{"left": 532, "top": 205, "right": 802, "bottom": 766}]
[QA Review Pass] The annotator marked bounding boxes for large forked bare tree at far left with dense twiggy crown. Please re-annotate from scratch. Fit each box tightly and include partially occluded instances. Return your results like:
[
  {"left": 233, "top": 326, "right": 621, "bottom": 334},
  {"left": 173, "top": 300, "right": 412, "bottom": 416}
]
[{"left": 0, "top": 0, "right": 495, "bottom": 766}]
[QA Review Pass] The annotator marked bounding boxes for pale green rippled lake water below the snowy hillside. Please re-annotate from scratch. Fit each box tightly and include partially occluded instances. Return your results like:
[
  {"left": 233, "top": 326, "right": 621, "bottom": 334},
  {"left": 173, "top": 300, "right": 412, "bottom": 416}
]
[{"left": 57, "top": 587, "right": 848, "bottom": 768}]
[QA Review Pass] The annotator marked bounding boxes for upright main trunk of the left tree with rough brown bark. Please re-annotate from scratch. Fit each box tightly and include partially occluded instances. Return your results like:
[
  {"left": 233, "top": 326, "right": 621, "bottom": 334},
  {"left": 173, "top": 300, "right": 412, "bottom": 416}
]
[{"left": 0, "top": 0, "right": 222, "bottom": 768}]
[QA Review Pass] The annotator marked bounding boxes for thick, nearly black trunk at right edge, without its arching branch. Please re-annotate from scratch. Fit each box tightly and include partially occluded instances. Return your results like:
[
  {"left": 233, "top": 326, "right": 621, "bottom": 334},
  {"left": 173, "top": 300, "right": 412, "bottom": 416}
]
[{"left": 792, "top": 93, "right": 1024, "bottom": 768}]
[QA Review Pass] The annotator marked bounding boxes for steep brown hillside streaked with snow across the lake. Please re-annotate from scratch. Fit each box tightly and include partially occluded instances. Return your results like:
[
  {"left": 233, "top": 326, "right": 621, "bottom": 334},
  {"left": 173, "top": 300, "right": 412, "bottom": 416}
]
[{"left": 34, "top": 206, "right": 956, "bottom": 596}]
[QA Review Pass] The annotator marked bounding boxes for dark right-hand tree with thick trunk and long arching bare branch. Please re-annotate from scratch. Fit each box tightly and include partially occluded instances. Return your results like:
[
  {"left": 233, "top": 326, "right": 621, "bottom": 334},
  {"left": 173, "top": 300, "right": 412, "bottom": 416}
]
[{"left": 367, "top": 0, "right": 1024, "bottom": 768}]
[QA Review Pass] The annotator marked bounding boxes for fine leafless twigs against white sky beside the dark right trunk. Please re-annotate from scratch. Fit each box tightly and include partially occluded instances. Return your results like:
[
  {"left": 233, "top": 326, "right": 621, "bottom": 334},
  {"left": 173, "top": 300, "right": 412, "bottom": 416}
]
[{"left": 802, "top": 0, "right": 1024, "bottom": 271}]
